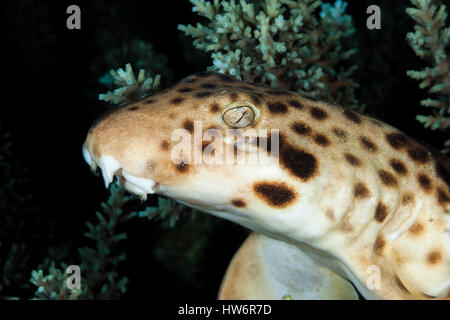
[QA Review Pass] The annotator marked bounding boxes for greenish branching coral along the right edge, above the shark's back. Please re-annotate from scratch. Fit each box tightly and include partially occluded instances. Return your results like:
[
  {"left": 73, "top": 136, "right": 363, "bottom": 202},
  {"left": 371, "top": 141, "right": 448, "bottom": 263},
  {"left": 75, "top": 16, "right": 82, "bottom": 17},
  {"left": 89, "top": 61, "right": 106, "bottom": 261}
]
[{"left": 406, "top": 0, "right": 450, "bottom": 152}]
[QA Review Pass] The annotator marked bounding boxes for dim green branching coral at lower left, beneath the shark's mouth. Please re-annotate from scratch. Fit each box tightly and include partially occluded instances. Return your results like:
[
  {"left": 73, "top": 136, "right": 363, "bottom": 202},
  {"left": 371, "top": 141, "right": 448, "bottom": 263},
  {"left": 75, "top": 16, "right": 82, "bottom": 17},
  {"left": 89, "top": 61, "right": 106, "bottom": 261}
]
[{"left": 30, "top": 182, "right": 137, "bottom": 299}]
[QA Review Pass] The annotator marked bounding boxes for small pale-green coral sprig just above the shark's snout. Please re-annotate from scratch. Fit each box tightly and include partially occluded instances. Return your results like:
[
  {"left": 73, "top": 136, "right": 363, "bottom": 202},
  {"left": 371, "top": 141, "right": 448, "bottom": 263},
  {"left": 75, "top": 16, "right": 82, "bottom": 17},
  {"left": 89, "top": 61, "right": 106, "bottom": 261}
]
[{"left": 98, "top": 64, "right": 161, "bottom": 104}]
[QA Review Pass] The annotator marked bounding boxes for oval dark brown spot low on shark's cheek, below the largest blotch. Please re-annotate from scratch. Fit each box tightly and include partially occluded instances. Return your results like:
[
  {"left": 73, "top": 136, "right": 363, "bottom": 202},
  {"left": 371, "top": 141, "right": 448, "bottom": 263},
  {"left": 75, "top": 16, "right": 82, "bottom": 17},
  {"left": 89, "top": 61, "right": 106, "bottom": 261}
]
[{"left": 253, "top": 182, "right": 295, "bottom": 208}]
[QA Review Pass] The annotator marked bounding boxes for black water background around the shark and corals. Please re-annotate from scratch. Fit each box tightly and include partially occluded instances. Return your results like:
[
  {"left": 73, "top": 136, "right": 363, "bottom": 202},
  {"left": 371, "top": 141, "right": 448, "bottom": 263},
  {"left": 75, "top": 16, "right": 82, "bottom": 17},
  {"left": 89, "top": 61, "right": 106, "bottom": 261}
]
[{"left": 0, "top": 0, "right": 448, "bottom": 299}]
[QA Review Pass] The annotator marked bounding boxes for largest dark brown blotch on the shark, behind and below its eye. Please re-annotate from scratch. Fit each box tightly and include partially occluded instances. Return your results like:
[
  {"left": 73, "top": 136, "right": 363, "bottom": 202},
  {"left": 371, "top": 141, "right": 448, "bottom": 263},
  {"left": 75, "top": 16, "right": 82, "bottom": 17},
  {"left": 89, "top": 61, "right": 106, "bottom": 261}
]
[{"left": 280, "top": 135, "right": 318, "bottom": 181}]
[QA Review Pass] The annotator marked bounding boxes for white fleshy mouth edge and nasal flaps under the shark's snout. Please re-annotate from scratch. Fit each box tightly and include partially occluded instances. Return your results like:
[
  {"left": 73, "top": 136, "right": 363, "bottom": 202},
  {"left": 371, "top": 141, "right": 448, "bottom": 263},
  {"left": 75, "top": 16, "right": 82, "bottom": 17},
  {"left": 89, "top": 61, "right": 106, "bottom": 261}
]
[{"left": 83, "top": 145, "right": 158, "bottom": 200}]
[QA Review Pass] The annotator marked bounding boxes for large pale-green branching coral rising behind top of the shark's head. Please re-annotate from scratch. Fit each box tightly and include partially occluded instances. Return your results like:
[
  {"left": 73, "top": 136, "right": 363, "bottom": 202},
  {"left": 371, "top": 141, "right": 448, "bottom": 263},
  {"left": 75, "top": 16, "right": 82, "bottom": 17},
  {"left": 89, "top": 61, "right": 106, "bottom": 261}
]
[{"left": 178, "top": 0, "right": 358, "bottom": 107}]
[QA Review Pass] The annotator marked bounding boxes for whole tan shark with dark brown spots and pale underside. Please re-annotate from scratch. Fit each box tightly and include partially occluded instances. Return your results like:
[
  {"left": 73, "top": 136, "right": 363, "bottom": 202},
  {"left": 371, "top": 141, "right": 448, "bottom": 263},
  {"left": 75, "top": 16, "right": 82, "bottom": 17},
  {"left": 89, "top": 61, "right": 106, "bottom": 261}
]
[{"left": 83, "top": 72, "right": 450, "bottom": 299}]
